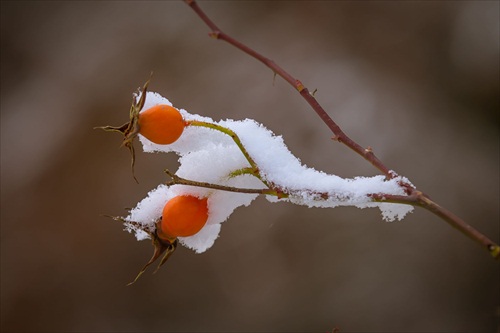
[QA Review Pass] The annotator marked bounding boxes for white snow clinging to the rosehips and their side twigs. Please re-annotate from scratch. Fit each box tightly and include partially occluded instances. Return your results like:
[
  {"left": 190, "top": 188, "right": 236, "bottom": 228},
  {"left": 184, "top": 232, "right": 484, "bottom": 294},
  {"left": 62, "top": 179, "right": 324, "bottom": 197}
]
[{"left": 125, "top": 92, "right": 413, "bottom": 253}]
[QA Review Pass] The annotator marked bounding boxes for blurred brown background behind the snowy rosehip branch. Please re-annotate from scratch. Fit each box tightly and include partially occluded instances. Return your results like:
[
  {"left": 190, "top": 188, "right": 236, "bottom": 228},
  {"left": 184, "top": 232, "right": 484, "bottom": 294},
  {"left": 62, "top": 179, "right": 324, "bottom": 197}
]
[{"left": 1, "top": 1, "right": 500, "bottom": 332}]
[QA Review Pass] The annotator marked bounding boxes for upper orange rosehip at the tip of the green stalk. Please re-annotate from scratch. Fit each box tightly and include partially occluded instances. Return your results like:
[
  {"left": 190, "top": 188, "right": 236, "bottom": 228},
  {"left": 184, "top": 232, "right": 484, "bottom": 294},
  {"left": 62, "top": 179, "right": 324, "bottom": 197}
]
[{"left": 139, "top": 105, "right": 186, "bottom": 145}]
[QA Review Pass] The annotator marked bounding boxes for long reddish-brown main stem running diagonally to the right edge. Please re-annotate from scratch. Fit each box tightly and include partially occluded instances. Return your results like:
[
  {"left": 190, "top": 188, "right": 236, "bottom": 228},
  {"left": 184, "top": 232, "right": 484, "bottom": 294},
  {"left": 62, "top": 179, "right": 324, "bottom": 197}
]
[{"left": 184, "top": 0, "right": 500, "bottom": 259}]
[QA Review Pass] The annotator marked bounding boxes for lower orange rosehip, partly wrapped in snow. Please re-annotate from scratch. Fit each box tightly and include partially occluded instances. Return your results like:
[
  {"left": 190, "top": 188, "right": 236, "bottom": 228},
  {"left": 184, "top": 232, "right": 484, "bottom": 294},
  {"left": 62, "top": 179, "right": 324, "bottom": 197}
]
[{"left": 159, "top": 195, "right": 208, "bottom": 240}]
